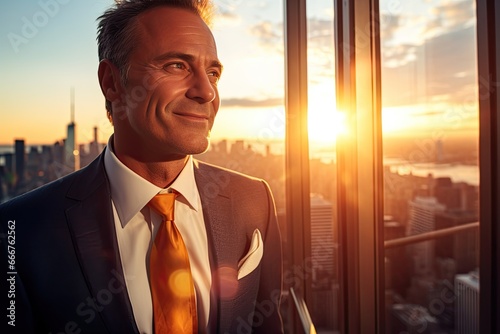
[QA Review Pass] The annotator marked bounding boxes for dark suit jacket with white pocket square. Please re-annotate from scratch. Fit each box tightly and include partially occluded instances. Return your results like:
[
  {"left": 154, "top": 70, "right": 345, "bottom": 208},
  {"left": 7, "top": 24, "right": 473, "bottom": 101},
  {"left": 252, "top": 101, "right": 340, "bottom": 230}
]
[{"left": 0, "top": 154, "right": 282, "bottom": 334}]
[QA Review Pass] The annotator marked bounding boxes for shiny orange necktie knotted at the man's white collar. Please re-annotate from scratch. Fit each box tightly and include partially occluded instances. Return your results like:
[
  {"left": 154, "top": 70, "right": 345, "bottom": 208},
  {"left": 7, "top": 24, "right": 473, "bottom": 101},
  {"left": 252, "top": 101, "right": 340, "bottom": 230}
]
[{"left": 148, "top": 193, "right": 198, "bottom": 334}]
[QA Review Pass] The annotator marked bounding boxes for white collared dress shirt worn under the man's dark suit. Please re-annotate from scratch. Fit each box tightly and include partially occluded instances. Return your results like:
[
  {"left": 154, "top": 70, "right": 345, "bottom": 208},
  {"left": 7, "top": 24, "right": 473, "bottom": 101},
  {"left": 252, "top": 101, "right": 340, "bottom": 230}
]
[{"left": 104, "top": 142, "right": 212, "bottom": 333}]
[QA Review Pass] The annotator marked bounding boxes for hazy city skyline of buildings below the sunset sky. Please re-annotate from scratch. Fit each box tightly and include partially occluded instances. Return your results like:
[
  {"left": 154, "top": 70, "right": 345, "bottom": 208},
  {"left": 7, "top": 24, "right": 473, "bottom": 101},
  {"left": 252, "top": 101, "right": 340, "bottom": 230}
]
[{"left": 0, "top": 114, "right": 478, "bottom": 333}]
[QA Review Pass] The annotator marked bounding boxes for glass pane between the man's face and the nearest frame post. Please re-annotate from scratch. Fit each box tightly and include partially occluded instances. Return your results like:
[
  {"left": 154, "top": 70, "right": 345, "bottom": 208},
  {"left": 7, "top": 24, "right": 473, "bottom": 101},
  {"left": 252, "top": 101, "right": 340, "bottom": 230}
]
[{"left": 205, "top": 0, "right": 293, "bottom": 332}]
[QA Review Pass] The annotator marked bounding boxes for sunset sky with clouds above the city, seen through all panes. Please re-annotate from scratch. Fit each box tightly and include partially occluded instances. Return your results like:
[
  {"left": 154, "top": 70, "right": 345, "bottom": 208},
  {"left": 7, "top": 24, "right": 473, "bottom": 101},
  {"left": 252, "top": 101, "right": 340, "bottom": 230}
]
[{"left": 0, "top": 0, "right": 477, "bottom": 145}]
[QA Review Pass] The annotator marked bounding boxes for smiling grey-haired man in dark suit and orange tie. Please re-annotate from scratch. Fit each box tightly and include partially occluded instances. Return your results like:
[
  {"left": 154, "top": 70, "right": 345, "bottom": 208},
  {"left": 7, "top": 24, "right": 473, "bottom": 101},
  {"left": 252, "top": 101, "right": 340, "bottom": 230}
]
[{"left": 0, "top": 0, "right": 282, "bottom": 334}]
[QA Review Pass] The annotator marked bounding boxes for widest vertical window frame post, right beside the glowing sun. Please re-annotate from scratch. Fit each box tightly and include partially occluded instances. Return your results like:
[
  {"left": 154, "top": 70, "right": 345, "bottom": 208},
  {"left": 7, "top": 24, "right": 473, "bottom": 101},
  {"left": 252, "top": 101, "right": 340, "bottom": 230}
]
[{"left": 334, "top": 0, "right": 385, "bottom": 333}]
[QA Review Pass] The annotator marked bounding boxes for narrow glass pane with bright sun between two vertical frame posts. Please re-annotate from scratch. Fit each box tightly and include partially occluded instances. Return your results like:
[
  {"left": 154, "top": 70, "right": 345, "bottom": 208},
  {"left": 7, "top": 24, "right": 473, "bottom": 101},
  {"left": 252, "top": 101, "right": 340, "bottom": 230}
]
[{"left": 306, "top": 0, "right": 343, "bottom": 333}]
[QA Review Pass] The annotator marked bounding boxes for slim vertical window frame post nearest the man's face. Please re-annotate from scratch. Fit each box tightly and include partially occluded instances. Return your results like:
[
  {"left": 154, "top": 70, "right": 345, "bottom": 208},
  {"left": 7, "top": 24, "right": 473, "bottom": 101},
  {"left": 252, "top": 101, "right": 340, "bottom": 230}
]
[{"left": 283, "top": 0, "right": 312, "bottom": 332}]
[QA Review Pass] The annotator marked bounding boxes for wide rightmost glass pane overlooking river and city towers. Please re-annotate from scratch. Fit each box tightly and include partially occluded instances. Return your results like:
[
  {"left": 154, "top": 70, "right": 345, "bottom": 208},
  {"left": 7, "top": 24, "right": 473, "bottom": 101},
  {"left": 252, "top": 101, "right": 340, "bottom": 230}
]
[{"left": 380, "top": 0, "right": 479, "bottom": 333}]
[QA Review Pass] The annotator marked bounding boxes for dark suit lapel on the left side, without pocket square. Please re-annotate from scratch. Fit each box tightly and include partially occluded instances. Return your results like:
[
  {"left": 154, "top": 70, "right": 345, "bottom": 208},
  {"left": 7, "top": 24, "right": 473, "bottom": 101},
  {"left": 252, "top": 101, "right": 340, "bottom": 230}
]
[{"left": 66, "top": 154, "right": 138, "bottom": 333}]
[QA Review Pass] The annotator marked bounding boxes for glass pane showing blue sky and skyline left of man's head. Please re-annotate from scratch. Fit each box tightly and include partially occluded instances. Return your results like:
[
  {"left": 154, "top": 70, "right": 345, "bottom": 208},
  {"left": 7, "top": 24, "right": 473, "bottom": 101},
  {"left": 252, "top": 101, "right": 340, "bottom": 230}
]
[{"left": 0, "top": 1, "right": 112, "bottom": 198}]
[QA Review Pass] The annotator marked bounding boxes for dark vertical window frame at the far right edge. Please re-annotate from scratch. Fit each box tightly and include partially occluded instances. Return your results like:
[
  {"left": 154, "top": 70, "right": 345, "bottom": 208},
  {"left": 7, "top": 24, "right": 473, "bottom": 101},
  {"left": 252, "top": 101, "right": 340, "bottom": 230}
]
[{"left": 476, "top": 0, "right": 500, "bottom": 333}]
